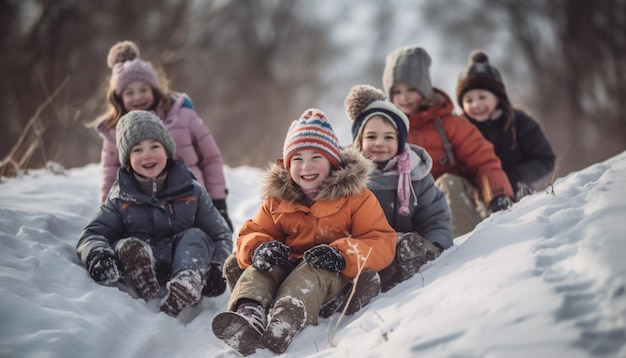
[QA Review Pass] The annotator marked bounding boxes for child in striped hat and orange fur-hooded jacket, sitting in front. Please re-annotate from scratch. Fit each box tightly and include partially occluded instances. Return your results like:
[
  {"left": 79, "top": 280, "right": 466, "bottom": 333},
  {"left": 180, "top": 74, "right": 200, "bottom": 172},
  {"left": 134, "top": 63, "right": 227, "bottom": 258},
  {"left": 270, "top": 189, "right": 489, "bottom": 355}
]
[{"left": 213, "top": 109, "right": 396, "bottom": 355}]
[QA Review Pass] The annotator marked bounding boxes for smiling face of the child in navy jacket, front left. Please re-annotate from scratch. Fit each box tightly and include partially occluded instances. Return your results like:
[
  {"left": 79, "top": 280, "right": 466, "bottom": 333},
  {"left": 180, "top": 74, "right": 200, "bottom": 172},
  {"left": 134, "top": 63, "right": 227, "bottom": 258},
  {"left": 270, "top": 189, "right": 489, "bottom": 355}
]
[{"left": 130, "top": 139, "right": 167, "bottom": 178}]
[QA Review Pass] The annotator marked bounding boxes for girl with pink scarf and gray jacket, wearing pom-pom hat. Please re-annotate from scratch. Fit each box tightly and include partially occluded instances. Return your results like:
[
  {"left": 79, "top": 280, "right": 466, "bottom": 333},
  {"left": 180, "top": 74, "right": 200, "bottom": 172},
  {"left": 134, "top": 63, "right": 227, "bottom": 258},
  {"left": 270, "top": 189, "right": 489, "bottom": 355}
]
[{"left": 345, "top": 85, "right": 454, "bottom": 299}]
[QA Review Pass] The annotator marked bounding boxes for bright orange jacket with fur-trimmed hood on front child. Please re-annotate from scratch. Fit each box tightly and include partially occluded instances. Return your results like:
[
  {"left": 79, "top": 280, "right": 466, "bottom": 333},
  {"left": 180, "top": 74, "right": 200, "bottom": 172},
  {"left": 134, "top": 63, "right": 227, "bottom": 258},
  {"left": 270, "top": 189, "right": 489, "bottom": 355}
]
[{"left": 237, "top": 147, "right": 396, "bottom": 280}]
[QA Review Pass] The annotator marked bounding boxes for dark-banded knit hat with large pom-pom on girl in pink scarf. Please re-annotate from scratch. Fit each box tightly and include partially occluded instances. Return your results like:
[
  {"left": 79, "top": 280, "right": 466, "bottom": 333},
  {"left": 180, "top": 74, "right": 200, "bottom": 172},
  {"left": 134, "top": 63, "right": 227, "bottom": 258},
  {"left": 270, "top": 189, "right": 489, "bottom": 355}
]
[{"left": 344, "top": 85, "right": 409, "bottom": 155}]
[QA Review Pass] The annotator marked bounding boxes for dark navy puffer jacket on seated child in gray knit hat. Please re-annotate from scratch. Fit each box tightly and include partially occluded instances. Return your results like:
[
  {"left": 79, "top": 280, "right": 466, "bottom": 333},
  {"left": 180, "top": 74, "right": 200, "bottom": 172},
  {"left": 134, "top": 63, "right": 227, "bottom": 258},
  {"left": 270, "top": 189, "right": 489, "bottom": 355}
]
[{"left": 76, "top": 160, "right": 233, "bottom": 279}]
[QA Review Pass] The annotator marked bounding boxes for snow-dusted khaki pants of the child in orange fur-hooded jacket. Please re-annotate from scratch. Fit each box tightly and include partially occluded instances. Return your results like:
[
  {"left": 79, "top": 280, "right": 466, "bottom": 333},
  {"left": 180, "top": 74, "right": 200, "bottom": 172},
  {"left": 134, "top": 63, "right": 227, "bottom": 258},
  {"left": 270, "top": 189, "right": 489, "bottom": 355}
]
[{"left": 224, "top": 255, "right": 350, "bottom": 325}]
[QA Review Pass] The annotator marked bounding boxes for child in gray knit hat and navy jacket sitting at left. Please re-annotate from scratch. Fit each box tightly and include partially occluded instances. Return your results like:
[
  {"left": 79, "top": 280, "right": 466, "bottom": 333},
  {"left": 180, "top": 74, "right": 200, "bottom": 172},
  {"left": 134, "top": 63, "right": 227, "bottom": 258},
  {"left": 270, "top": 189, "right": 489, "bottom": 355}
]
[{"left": 76, "top": 111, "right": 233, "bottom": 316}]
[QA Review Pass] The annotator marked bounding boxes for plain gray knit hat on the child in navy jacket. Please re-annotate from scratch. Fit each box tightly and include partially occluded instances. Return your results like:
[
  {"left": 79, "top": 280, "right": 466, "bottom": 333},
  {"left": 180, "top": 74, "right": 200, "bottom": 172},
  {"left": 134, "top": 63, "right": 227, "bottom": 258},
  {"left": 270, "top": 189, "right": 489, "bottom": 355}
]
[{"left": 115, "top": 111, "right": 176, "bottom": 168}]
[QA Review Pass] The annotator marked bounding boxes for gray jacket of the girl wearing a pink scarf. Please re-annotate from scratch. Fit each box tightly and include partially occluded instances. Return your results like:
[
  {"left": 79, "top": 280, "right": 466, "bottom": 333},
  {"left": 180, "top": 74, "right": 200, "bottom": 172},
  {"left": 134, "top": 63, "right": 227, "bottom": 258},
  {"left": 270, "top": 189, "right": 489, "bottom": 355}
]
[{"left": 368, "top": 144, "right": 454, "bottom": 250}]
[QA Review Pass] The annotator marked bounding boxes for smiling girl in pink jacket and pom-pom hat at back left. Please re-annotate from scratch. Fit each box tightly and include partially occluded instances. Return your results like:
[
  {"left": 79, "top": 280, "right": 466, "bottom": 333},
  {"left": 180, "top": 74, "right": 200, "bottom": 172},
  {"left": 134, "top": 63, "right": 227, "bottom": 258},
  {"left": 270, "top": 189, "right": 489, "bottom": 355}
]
[{"left": 90, "top": 41, "right": 232, "bottom": 230}]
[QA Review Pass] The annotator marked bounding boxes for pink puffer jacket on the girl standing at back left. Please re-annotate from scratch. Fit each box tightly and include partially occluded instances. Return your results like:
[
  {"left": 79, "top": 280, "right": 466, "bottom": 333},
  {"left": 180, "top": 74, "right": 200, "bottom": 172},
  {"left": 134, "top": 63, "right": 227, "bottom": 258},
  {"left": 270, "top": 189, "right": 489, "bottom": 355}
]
[{"left": 97, "top": 93, "right": 226, "bottom": 203}]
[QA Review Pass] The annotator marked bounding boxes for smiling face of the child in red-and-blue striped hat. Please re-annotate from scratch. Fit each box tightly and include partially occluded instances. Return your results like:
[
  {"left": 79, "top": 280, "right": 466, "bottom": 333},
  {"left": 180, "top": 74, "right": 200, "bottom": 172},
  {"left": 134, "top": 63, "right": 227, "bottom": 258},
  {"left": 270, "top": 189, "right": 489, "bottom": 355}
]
[{"left": 289, "top": 149, "right": 331, "bottom": 190}]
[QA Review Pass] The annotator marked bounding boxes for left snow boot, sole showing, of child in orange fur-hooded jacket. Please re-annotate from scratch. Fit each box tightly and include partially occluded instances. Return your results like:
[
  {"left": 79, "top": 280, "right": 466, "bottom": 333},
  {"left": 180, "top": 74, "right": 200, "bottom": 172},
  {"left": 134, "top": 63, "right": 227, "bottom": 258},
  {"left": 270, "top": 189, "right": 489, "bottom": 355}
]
[{"left": 212, "top": 299, "right": 267, "bottom": 356}]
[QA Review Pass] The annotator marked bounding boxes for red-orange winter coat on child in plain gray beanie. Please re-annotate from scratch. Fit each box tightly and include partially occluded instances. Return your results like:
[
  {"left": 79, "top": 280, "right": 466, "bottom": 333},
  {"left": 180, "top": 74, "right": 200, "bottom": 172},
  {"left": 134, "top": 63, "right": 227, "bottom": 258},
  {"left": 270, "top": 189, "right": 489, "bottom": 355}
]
[{"left": 408, "top": 88, "right": 514, "bottom": 204}]
